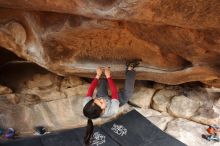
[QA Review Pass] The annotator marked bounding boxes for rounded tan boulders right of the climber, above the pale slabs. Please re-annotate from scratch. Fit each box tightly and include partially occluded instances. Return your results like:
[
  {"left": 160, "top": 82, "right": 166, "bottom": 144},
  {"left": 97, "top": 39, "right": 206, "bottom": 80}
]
[{"left": 150, "top": 86, "right": 220, "bottom": 125}]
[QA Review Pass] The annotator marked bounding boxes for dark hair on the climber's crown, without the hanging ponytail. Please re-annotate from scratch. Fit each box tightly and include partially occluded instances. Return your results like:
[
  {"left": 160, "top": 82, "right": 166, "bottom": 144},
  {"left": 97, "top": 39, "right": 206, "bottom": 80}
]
[{"left": 83, "top": 99, "right": 102, "bottom": 119}]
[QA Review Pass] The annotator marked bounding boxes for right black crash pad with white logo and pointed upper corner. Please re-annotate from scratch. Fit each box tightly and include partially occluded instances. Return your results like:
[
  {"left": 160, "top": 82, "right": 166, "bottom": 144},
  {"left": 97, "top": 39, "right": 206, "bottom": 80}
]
[{"left": 101, "top": 110, "right": 185, "bottom": 146}]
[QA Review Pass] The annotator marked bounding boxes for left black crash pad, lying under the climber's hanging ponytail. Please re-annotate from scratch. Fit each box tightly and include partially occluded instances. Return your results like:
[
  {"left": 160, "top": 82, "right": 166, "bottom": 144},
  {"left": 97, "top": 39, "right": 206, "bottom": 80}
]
[{"left": 0, "top": 126, "right": 120, "bottom": 146}]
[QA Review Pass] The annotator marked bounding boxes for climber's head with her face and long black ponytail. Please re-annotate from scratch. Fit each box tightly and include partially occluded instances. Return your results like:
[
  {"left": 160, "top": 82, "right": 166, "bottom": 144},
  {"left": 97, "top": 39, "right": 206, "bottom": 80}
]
[{"left": 83, "top": 98, "right": 106, "bottom": 145}]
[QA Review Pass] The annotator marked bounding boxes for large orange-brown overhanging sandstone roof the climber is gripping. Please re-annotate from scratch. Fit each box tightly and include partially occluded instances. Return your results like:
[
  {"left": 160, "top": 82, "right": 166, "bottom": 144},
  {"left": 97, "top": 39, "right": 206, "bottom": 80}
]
[{"left": 0, "top": 0, "right": 220, "bottom": 87}]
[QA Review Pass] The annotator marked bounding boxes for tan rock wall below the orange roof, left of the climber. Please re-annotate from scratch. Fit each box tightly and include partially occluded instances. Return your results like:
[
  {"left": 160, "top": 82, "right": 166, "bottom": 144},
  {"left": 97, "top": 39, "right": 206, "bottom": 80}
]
[{"left": 0, "top": 70, "right": 131, "bottom": 135}]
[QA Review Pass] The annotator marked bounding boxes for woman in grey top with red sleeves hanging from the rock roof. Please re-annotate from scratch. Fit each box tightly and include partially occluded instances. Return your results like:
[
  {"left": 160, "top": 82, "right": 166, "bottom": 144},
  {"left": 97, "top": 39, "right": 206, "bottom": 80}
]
[{"left": 83, "top": 61, "right": 139, "bottom": 145}]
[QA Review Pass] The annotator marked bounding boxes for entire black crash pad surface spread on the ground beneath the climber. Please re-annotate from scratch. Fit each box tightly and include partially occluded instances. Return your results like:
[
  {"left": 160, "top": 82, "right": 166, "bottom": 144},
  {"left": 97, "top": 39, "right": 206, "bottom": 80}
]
[{"left": 0, "top": 110, "right": 185, "bottom": 146}]
